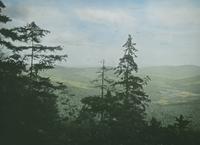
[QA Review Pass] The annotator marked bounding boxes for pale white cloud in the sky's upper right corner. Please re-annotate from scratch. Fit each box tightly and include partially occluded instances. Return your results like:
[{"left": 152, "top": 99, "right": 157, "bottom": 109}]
[{"left": 146, "top": 2, "right": 200, "bottom": 27}]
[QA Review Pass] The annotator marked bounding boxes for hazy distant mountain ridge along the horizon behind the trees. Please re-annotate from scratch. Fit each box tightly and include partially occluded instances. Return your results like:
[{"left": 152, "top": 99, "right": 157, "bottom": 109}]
[{"left": 48, "top": 65, "right": 200, "bottom": 79}]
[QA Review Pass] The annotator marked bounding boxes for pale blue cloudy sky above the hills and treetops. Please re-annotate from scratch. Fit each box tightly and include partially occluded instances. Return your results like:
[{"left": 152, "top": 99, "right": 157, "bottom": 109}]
[{"left": 3, "top": 0, "right": 200, "bottom": 66}]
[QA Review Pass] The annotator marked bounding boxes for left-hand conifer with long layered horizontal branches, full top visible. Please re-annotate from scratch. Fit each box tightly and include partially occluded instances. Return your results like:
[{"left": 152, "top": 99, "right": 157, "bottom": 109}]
[{"left": 15, "top": 22, "right": 67, "bottom": 144}]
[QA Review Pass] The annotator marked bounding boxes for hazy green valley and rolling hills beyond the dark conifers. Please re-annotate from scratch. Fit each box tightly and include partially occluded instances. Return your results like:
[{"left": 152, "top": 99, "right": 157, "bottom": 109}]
[{"left": 43, "top": 66, "right": 200, "bottom": 126}]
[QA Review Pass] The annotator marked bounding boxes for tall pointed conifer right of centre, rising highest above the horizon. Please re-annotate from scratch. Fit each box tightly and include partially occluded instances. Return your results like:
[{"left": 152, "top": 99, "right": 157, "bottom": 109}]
[{"left": 115, "top": 35, "right": 149, "bottom": 120}]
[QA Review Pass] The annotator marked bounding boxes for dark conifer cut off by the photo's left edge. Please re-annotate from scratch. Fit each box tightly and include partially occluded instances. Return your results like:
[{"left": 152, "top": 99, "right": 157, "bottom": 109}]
[{"left": 0, "top": 1, "right": 25, "bottom": 145}]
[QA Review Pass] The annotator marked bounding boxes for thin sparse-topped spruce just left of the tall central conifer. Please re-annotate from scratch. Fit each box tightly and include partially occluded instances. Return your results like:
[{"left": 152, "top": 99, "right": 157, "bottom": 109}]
[{"left": 74, "top": 60, "right": 115, "bottom": 145}]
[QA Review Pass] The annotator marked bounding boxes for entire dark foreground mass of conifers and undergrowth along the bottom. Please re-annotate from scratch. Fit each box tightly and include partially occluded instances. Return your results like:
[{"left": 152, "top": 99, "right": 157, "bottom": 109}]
[{"left": 0, "top": 1, "right": 200, "bottom": 145}]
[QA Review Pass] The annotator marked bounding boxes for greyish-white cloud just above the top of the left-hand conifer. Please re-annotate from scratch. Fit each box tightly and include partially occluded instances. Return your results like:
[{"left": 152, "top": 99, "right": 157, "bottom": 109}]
[{"left": 6, "top": 3, "right": 70, "bottom": 31}]
